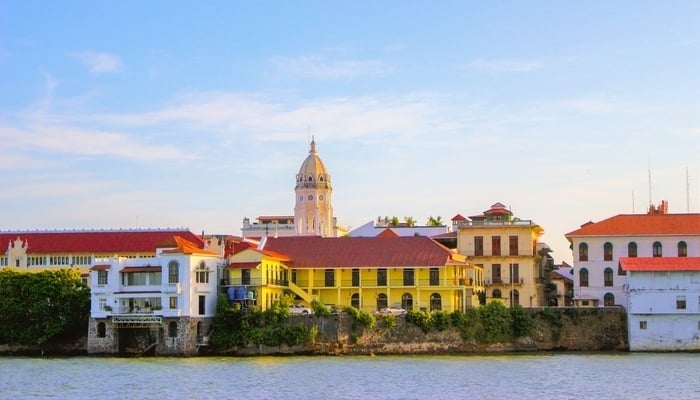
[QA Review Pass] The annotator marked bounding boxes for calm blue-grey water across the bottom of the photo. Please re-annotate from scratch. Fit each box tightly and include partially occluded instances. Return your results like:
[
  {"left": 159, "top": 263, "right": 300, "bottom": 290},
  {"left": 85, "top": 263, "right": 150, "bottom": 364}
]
[{"left": 0, "top": 353, "right": 700, "bottom": 400}]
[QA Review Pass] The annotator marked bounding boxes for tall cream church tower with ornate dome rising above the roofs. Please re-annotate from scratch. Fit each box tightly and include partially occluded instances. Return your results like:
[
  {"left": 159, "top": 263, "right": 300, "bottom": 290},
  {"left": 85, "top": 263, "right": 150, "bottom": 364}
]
[{"left": 294, "top": 138, "right": 337, "bottom": 237}]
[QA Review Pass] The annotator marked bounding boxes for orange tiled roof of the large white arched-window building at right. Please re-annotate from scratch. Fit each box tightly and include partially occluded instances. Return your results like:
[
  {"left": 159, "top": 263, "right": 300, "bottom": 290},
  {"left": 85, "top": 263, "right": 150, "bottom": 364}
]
[{"left": 565, "top": 214, "right": 700, "bottom": 238}]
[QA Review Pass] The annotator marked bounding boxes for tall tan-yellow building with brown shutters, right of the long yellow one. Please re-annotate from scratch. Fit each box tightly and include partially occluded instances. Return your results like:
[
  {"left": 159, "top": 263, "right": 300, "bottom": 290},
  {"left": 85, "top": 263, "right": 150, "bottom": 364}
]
[{"left": 453, "top": 203, "right": 546, "bottom": 307}]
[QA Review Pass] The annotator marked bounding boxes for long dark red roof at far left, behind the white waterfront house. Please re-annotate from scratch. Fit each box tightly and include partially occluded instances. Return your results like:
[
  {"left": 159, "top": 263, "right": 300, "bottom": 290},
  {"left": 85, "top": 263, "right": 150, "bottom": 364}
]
[{"left": 0, "top": 229, "right": 204, "bottom": 254}]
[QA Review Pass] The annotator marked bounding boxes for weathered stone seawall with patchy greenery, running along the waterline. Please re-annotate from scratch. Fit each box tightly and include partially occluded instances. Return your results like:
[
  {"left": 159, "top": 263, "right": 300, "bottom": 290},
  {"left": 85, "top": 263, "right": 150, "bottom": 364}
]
[{"left": 0, "top": 308, "right": 629, "bottom": 356}]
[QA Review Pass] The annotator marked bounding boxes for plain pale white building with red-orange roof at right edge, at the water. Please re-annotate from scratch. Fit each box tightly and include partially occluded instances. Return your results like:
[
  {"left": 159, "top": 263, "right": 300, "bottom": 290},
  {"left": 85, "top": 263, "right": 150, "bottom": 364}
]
[{"left": 620, "top": 257, "right": 700, "bottom": 351}]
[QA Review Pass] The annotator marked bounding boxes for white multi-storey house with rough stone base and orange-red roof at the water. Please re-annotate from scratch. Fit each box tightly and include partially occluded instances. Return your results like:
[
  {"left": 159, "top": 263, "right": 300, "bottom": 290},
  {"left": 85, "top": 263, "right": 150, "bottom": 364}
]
[{"left": 87, "top": 236, "right": 223, "bottom": 355}]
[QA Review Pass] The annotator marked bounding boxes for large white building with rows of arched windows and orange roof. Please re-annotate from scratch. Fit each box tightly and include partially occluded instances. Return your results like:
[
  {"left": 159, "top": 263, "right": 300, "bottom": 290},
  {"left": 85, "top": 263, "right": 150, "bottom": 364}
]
[{"left": 566, "top": 202, "right": 700, "bottom": 307}]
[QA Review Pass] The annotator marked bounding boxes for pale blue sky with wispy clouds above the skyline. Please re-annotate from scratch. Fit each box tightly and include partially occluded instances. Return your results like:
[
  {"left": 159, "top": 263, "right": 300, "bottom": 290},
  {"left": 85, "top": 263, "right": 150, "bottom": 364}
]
[{"left": 0, "top": 0, "right": 700, "bottom": 263}]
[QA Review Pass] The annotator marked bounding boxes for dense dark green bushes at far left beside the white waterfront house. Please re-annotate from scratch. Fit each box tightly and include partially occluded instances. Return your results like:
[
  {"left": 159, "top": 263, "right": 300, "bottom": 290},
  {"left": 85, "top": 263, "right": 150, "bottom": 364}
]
[{"left": 0, "top": 268, "right": 90, "bottom": 345}]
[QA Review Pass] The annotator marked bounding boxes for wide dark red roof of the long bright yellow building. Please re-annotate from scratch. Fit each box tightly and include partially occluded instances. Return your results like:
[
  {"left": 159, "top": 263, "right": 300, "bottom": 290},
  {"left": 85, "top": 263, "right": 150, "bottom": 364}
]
[{"left": 265, "top": 236, "right": 460, "bottom": 268}]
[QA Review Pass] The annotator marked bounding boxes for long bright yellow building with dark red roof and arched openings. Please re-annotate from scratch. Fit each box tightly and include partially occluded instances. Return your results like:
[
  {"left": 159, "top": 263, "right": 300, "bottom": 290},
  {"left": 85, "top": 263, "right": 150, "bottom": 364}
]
[{"left": 226, "top": 236, "right": 483, "bottom": 312}]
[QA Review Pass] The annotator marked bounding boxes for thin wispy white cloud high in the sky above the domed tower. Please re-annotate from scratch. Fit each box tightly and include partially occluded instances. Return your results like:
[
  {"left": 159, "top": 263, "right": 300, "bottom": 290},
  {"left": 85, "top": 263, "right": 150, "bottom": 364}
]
[{"left": 270, "top": 56, "right": 393, "bottom": 80}]
